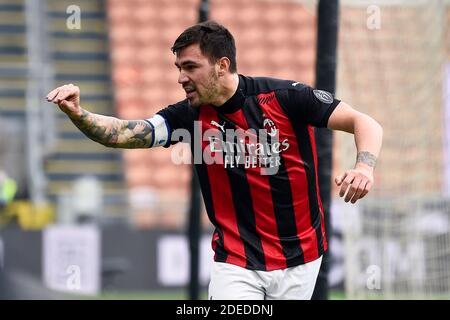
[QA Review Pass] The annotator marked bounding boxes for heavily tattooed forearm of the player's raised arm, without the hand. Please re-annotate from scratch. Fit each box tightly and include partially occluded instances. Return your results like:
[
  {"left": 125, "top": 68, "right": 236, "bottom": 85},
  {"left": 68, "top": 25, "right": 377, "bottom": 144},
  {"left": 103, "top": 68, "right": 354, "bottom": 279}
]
[{"left": 71, "top": 110, "right": 153, "bottom": 148}]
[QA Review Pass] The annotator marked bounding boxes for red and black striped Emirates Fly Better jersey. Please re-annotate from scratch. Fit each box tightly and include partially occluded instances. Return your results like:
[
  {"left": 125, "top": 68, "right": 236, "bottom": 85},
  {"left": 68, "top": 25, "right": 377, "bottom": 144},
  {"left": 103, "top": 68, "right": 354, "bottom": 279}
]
[{"left": 153, "top": 75, "right": 339, "bottom": 271}]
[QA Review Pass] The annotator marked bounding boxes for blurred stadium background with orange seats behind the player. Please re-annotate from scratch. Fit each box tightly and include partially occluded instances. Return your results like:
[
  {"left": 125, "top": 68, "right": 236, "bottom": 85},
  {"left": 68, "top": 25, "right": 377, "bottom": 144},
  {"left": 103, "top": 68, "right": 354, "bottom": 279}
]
[{"left": 0, "top": 0, "right": 450, "bottom": 299}]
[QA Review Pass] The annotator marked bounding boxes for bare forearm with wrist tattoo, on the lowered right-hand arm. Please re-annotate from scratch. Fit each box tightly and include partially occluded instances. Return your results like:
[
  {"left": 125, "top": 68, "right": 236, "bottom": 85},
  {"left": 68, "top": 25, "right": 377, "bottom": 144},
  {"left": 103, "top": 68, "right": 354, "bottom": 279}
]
[{"left": 354, "top": 115, "right": 383, "bottom": 168}]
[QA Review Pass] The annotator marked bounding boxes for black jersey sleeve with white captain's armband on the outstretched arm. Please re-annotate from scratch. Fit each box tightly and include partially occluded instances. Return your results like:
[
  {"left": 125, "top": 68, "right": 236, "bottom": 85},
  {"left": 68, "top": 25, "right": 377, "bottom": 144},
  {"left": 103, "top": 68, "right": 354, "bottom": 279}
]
[{"left": 147, "top": 100, "right": 193, "bottom": 148}]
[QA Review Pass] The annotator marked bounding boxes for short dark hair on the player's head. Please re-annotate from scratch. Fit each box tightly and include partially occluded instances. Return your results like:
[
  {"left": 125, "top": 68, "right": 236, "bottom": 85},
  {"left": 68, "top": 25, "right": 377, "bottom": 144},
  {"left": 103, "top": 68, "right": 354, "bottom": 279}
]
[{"left": 171, "top": 21, "right": 237, "bottom": 73}]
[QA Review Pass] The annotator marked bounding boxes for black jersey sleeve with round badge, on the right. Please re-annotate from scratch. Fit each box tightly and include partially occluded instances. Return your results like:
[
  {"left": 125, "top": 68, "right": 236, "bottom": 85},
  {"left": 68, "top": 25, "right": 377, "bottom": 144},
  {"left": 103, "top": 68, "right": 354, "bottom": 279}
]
[{"left": 279, "top": 85, "right": 340, "bottom": 128}]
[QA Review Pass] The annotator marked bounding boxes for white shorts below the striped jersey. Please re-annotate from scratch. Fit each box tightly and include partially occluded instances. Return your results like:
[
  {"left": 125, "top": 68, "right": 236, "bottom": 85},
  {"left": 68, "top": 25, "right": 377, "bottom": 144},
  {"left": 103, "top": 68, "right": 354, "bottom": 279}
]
[{"left": 208, "top": 257, "right": 322, "bottom": 300}]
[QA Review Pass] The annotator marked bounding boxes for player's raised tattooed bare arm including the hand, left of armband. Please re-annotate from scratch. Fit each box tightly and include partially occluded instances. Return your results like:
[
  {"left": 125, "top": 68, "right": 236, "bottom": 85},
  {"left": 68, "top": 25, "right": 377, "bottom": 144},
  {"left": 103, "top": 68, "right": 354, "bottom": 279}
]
[{"left": 47, "top": 84, "right": 153, "bottom": 149}]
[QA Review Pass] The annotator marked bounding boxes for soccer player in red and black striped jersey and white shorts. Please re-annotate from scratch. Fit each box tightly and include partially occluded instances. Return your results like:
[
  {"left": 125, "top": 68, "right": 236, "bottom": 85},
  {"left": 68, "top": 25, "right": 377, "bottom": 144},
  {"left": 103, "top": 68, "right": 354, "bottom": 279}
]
[{"left": 47, "top": 21, "right": 382, "bottom": 299}]
